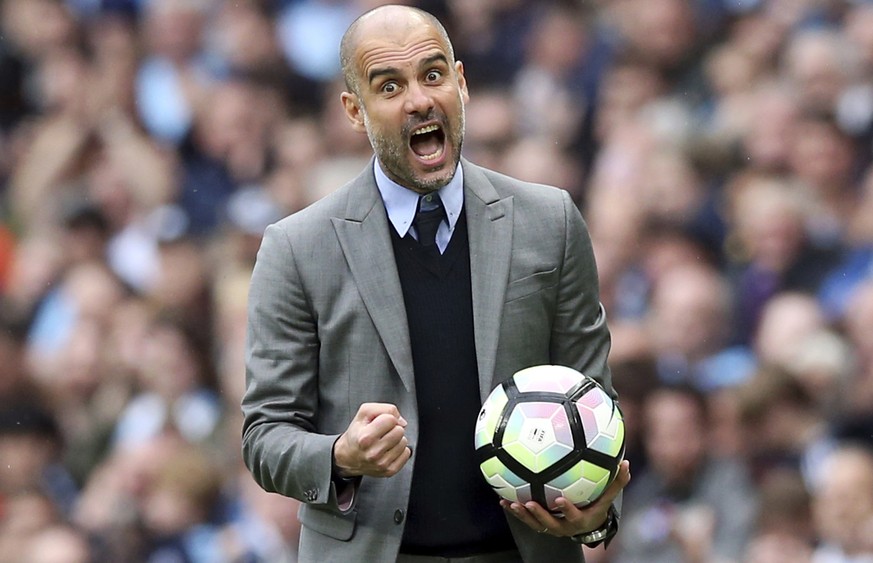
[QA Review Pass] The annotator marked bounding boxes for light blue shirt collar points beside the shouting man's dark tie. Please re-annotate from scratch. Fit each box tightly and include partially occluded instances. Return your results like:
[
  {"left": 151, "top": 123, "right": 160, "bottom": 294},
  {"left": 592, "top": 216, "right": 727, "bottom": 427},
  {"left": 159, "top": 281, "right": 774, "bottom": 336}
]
[{"left": 373, "top": 158, "right": 464, "bottom": 238}]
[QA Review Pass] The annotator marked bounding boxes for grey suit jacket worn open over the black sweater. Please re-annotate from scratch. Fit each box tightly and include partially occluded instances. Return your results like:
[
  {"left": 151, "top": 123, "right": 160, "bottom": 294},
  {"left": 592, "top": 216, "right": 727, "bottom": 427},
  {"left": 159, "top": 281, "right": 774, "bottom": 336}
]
[{"left": 242, "top": 160, "right": 612, "bottom": 562}]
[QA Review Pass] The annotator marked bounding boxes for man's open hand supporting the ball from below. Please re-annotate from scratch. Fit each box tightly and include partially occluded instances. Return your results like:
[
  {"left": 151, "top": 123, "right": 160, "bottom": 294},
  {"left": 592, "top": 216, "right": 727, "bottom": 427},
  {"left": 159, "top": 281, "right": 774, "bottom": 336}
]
[{"left": 500, "top": 460, "right": 630, "bottom": 537}]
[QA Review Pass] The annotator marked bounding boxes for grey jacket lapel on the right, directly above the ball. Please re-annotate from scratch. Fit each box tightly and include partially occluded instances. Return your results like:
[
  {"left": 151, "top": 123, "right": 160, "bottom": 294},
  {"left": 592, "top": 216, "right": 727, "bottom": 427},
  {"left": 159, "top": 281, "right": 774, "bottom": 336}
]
[{"left": 463, "top": 160, "right": 513, "bottom": 400}]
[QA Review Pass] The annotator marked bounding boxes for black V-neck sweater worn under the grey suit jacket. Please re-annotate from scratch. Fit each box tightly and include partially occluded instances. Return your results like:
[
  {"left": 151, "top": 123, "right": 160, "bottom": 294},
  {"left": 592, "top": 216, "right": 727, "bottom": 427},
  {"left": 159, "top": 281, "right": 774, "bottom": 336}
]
[{"left": 391, "top": 213, "right": 515, "bottom": 557}]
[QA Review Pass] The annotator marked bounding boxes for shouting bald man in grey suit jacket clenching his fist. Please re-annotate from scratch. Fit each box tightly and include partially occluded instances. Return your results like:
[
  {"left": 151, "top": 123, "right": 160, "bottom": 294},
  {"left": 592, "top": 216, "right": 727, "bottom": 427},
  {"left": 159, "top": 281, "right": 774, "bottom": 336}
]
[{"left": 243, "top": 6, "right": 630, "bottom": 562}]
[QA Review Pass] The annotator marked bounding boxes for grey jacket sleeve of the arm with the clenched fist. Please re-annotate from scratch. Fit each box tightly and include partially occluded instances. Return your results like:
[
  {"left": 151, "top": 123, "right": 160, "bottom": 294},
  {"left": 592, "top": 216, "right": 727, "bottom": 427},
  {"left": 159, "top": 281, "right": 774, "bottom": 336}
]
[{"left": 242, "top": 225, "right": 348, "bottom": 505}]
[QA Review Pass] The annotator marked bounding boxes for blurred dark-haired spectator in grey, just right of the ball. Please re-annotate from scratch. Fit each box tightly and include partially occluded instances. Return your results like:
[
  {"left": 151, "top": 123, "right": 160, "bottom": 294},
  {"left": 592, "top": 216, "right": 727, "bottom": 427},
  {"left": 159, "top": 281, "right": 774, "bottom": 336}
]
[{"left": 614, "top": 386, "right": 756, "bottom": 563}]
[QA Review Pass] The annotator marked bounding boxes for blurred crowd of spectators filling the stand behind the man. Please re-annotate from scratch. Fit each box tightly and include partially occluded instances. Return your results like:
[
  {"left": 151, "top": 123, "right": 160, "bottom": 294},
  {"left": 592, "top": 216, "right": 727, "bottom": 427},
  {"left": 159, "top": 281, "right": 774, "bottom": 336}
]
[{"left": 0, "top": 0, "right": 873, "bottom": 563}]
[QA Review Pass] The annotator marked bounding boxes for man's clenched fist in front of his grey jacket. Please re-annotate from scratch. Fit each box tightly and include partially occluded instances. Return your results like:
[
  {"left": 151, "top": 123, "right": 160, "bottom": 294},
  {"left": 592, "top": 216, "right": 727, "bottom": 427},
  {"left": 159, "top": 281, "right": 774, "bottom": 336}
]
[{"left": 333, "top": 403, "right": 412, "bottom": 477}]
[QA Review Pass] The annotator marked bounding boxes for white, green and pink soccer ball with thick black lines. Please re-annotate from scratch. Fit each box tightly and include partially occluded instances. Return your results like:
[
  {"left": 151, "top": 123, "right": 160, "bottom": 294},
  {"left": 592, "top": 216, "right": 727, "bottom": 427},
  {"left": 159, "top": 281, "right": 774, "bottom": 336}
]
[{"left": 474, "top": 365, "right": 624, "bottom": 512}]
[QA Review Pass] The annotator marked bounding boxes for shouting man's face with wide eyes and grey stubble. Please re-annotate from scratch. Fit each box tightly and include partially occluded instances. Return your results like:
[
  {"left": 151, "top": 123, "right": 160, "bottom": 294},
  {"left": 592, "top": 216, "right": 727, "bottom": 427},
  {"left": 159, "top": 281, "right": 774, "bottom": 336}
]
[{"left": 343, "top": 17, "right": 469, "bottom": 193}]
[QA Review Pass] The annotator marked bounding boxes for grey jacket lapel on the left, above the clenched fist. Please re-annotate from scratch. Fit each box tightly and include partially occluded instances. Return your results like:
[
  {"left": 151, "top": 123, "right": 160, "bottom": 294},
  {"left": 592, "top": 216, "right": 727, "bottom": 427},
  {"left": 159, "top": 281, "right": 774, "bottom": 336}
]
[{"left": 332, "top": 167, "right": 414, "bottom": 391}]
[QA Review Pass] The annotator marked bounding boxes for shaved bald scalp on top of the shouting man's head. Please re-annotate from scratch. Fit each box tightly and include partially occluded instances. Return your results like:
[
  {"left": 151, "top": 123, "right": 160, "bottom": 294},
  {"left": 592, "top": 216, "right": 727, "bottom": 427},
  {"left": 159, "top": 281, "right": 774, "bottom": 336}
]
[{"left": 340, "top": 4, "right": 455, "bottom": 94}]
